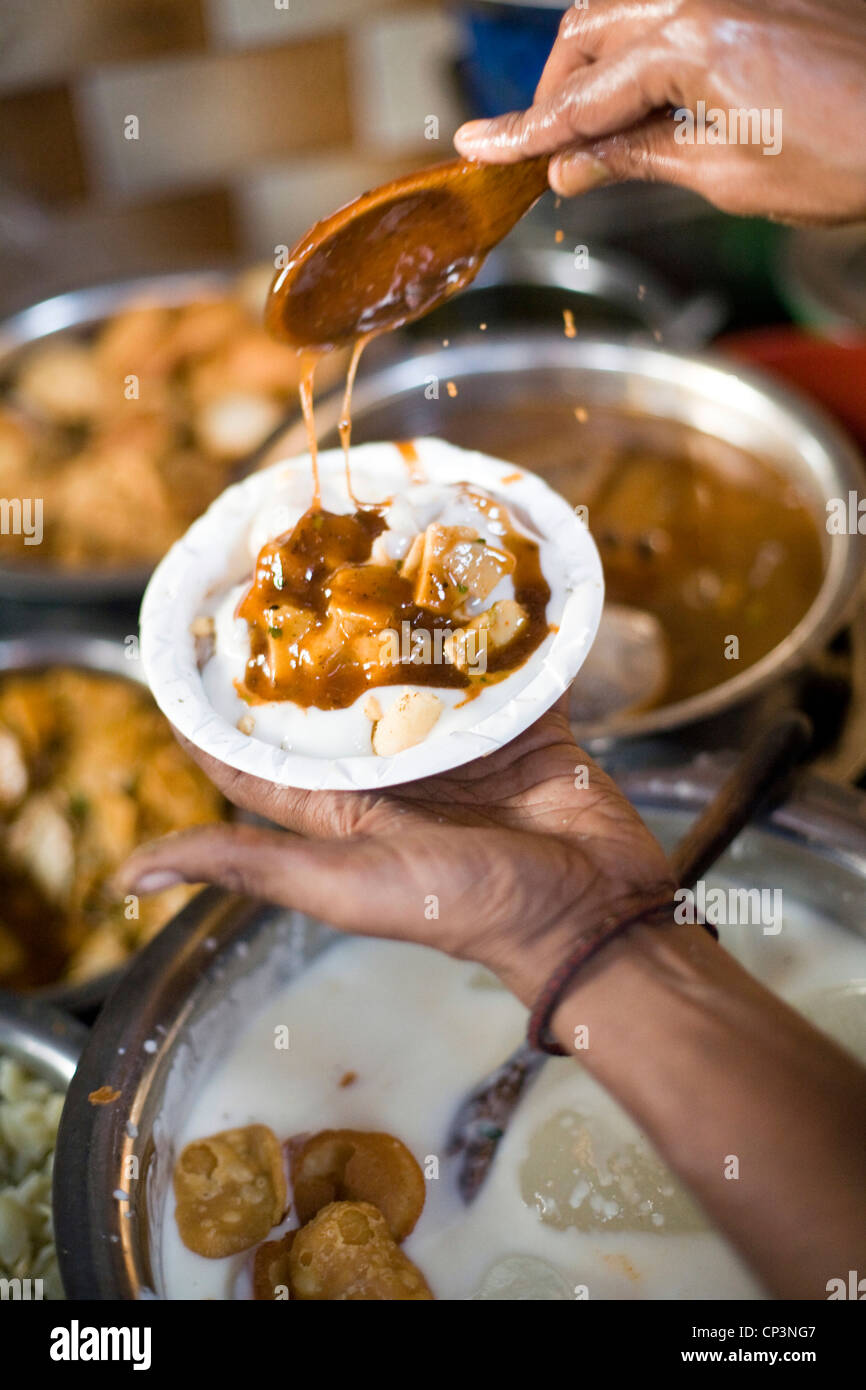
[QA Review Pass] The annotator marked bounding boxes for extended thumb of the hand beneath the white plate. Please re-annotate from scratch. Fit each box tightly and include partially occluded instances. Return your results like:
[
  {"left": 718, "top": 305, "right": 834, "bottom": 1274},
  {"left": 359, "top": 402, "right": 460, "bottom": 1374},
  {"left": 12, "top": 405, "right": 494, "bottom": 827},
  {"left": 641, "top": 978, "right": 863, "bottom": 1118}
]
[{"left": 115, "top": 826, "right": 411, "bottom": 935}]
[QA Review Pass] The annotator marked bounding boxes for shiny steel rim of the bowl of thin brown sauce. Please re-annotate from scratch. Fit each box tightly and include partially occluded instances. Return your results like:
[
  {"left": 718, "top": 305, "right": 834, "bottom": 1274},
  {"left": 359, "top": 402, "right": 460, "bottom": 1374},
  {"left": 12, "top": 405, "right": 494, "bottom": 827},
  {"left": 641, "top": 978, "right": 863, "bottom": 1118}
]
[{"left": 286, "top": 332, "right": 866, "bottom": 752}]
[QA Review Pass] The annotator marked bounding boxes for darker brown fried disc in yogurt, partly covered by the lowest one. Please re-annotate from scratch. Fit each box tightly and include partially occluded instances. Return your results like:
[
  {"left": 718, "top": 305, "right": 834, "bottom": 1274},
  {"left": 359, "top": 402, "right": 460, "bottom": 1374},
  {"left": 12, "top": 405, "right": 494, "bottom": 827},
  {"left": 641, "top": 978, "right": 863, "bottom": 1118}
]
[{"left": 291, "top": 1130, "right": 427, "bottom": 1243}]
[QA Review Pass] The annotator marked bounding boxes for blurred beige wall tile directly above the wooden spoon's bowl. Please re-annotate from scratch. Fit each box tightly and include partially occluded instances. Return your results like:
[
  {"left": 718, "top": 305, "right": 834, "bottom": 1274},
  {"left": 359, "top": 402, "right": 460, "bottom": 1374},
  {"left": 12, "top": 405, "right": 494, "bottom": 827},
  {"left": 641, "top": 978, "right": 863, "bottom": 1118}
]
[{"left": 235, "top": 150, "right": 428, "bottom": 259}]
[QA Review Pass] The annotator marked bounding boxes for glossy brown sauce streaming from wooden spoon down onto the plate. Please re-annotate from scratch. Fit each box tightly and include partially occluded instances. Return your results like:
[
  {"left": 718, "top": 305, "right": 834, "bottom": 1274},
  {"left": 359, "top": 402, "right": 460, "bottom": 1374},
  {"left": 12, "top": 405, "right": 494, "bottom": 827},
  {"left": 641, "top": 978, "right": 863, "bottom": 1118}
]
[{"left": 235, "top": 160, "right": 550, "bottom": 709}]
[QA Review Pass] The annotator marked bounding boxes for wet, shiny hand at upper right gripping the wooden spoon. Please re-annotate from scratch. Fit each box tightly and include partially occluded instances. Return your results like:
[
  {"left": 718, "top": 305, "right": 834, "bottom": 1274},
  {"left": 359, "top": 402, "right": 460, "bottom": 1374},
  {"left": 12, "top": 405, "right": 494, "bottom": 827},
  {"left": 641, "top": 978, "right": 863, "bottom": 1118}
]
[{"left": 455, "top": 0, "right": 866, "bottom": 222}]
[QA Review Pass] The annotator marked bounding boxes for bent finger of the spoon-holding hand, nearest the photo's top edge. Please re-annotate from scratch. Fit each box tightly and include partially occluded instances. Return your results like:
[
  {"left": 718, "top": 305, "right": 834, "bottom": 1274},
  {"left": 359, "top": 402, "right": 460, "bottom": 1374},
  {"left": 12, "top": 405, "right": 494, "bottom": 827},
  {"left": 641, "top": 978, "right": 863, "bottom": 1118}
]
[{"left": 535, "top": 0, "right": 680, "bottom": 101}]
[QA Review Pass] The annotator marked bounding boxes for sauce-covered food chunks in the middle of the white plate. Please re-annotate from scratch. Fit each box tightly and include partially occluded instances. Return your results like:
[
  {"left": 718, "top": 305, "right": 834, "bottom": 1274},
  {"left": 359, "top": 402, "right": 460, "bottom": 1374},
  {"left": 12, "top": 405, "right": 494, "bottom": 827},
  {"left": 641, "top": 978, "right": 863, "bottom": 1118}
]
[{"left": 236, "top": 487, "right": 550, "bottom": 717}]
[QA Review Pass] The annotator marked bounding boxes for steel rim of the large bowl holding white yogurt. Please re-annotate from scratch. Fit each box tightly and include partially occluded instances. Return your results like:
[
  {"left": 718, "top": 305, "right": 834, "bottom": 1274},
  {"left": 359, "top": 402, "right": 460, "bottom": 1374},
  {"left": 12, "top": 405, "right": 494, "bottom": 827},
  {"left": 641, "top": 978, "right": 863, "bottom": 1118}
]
[{"left": 54, "top": 756, "right": 866, "bottom": 1300}]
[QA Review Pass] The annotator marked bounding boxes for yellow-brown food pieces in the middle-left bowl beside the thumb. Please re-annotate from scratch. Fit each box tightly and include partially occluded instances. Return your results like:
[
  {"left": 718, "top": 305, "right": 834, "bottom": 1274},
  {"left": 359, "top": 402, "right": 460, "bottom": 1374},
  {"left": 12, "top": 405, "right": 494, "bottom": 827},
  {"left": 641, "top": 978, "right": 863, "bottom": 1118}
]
[{"left": 0, "top": 667, "right": 225, "bottom": 988}]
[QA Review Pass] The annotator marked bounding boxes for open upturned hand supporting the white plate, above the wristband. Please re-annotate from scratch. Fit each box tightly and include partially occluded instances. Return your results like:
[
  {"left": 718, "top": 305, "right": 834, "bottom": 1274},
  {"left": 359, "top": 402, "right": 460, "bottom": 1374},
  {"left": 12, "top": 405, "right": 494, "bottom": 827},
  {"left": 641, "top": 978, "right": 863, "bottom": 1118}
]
[{"left": 116, "top": 712, "right": 674, "bottom": 1004}]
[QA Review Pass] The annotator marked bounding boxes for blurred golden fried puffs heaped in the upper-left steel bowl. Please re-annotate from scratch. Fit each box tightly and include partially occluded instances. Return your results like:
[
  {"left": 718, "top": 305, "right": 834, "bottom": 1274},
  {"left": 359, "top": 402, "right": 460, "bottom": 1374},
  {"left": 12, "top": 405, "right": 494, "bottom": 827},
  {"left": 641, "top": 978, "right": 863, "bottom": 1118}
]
[{"left": 0, "top": 267, "right": 341, "bottom": 569}]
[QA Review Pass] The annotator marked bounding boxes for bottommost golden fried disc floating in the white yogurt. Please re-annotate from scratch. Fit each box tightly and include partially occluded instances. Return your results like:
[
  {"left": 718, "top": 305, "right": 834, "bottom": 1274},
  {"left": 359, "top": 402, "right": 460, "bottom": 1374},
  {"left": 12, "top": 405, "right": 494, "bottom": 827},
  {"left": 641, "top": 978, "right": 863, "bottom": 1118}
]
[{"left": 288, "top": 1202, "right": 432, "bottom": 1302}]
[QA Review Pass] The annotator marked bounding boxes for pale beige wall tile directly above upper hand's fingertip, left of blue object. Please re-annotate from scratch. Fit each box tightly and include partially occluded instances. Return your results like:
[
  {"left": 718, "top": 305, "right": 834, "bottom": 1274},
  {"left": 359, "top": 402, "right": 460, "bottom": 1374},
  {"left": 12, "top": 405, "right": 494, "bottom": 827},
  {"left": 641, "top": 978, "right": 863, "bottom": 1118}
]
[{"left": 352, "top": 6, "right": 461, "bottom": 158}]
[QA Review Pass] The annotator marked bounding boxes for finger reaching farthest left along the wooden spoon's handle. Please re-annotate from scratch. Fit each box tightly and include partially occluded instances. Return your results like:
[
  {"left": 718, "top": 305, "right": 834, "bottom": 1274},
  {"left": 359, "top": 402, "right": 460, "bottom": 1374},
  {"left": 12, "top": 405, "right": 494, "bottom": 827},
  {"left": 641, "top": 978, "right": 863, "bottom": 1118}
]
[{"left": 455, "top": 42, "right": 673, "bottom": 164}]
